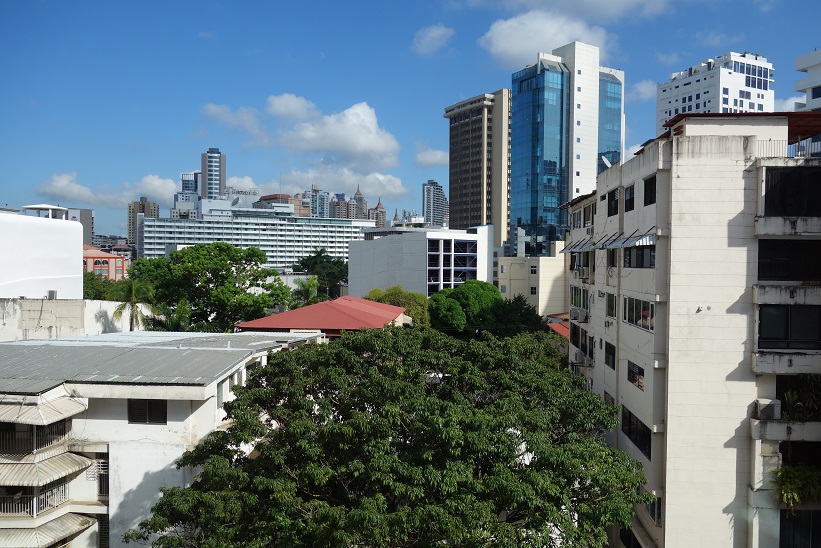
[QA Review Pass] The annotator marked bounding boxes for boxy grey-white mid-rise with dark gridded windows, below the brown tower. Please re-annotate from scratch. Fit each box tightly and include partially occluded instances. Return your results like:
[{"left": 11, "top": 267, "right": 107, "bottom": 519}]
[{"left": 348, "top": 225, "right": 493, "bottom": 297}]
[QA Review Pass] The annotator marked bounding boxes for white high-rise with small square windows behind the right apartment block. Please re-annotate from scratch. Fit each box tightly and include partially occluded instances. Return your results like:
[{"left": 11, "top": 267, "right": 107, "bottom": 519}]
[{"left": 656, "top": 52, "right": 775, "bottom": 135}]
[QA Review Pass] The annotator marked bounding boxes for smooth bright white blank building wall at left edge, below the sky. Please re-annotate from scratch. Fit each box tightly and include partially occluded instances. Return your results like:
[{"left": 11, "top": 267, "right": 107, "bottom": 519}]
[{"left": 0, "top": 214, "right": 83, "bottom": 299}]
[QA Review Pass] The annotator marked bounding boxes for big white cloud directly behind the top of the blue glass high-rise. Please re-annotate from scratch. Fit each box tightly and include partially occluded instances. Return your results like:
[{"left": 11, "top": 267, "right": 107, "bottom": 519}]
[{"left": 479, "top": 10, "right": 615, "bottom": 67}]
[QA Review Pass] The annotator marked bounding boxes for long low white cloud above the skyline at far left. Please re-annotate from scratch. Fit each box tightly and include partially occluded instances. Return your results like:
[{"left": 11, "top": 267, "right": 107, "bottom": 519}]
[{"left": 35, "top": 173, "right": 177, "bottom": 209}]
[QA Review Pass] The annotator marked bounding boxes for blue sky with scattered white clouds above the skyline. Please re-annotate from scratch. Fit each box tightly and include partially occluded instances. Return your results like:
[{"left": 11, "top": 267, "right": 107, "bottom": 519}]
[{"left": 0, "top": 0, "right": 821, "bottom": 234}]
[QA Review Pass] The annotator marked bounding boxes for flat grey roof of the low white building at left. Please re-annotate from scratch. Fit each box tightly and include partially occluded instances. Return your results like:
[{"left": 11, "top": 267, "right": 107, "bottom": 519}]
[{"left": 0, "top": 331, "right": 317, "bottom": 394}]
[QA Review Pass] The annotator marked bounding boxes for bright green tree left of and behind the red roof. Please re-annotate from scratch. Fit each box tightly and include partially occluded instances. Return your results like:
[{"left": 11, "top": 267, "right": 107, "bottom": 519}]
[{"left": 131, "top": 242, "right": 291, "bottom": 331}]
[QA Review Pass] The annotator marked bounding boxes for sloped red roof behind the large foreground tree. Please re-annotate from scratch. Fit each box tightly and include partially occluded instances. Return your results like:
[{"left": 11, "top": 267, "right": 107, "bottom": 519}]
[{"left": 236, "top": 296, "right": 405, "bottom": 331}]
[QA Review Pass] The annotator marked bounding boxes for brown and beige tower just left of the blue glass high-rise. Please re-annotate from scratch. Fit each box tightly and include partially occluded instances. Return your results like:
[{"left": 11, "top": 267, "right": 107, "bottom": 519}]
[{"left": 444, "top": 89, "right": 510, "bottom": 247}]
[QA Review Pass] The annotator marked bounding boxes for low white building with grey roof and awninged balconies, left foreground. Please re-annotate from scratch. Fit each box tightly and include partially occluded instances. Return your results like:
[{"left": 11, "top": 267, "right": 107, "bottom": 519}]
[{"left": 0, "top": 332, "right": 322, "bottom": 548}]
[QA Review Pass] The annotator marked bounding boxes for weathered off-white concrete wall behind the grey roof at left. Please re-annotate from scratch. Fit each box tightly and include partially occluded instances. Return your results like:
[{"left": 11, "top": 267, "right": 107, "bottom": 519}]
[{"left": 0, "top": 298, "right": 150, "bottom": 342}]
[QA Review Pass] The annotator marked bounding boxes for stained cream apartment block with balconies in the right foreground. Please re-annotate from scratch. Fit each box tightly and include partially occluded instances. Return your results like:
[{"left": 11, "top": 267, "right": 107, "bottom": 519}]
[{"left": 565, "top": 112, "right": 821, "bottom": 548}]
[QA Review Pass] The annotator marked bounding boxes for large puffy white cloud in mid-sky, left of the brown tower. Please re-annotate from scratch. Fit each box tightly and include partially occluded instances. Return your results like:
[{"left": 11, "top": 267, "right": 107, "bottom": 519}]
[{"left": 281, "top": 103, "right": 400, "bottom": 172}]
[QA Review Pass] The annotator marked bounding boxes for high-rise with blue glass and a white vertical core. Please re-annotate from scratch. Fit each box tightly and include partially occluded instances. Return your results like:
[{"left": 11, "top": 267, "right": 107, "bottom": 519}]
[{"left": 509, "top": 42, "right": 624, "bottom": 257}]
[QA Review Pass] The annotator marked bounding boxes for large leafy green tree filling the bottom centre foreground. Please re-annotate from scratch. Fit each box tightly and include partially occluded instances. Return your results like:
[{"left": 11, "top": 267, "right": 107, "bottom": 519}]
[{"left": 126, "top": 328, "right": 648, "bottom": 548}]
